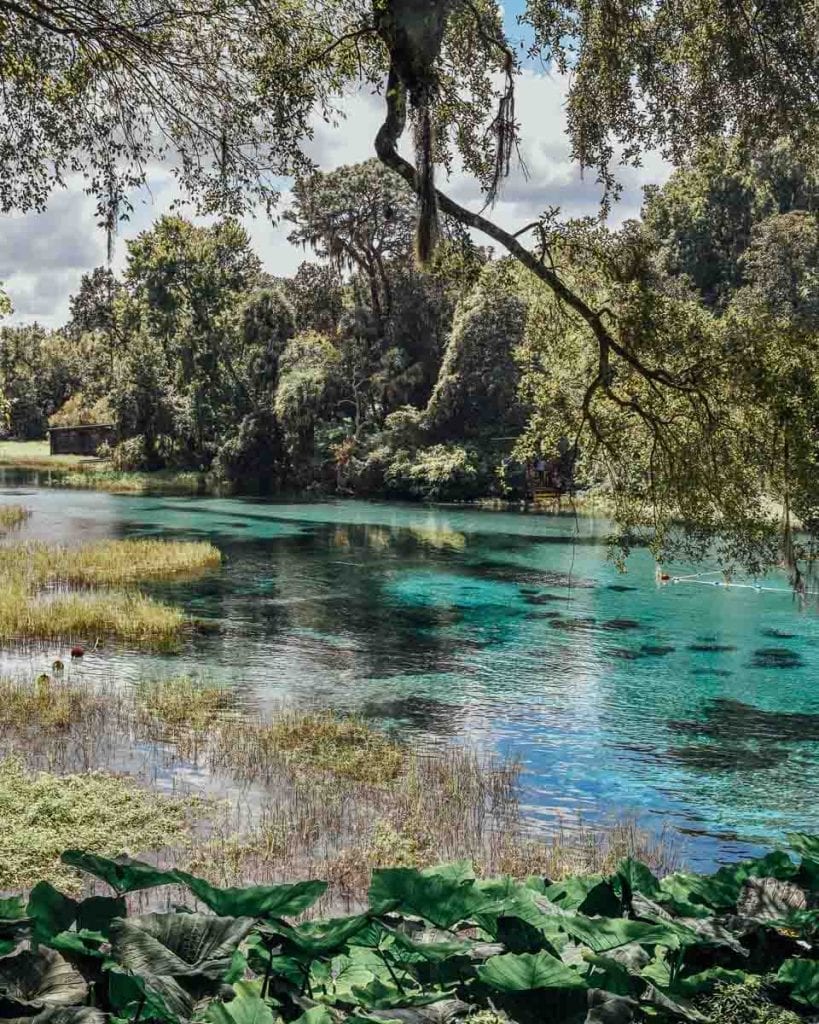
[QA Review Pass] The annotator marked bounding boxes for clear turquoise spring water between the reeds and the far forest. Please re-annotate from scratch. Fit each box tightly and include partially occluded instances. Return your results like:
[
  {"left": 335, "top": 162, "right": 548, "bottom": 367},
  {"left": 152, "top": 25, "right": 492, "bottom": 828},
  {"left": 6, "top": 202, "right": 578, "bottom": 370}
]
[{"left": 0, "top": 477, "right": 819, "bottom": 867}]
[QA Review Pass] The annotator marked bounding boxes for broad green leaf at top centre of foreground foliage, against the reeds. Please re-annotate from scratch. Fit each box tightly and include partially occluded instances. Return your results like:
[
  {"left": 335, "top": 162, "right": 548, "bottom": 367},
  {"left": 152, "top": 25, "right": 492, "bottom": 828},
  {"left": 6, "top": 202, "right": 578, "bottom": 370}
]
[{"left": 370, "top": 861, "right": 499, "bottom": 928}]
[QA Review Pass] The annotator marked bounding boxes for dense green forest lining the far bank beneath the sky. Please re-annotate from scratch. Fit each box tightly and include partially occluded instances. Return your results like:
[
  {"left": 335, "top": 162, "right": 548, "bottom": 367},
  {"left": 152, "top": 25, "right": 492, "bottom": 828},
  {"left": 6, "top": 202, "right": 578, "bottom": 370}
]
[{"left": 0, "top": 141, "right": 819, "bottom": 577}]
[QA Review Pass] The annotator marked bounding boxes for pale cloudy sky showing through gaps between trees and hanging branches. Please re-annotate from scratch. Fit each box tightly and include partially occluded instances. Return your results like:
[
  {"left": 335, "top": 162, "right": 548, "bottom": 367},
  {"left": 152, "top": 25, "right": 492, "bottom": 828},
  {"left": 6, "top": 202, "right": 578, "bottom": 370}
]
[{"left": 0, "top": 18, "right": 669, "bottom": 327}]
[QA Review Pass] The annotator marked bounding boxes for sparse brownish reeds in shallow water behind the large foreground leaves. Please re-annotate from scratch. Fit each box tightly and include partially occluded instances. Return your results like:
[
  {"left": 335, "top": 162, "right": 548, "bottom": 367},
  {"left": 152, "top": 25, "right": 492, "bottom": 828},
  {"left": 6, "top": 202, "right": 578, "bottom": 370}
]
[{"left": 0, "top": 679, "right": 680, "bottom": 913}]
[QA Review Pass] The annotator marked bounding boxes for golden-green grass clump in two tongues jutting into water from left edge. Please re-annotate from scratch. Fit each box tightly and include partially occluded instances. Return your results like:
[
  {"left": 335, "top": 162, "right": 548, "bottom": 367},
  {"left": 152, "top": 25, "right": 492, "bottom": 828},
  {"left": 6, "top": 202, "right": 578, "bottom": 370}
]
[{"left": 0, "top": 540, "right": 221, "bottom": 648}]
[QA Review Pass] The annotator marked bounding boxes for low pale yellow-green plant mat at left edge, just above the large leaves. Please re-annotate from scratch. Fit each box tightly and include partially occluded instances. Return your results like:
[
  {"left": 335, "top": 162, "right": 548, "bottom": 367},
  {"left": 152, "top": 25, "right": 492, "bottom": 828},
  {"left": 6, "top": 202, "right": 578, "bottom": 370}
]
[{"left": 0, "top": 756, "right": 197, "bottom": 890}]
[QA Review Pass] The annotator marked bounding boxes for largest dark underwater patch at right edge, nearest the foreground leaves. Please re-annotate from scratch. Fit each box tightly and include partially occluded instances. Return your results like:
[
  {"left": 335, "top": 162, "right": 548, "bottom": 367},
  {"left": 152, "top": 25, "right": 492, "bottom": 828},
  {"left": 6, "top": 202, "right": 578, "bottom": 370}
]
[{"left": 669, "top": 697, "right": 819, "bottom": 743}]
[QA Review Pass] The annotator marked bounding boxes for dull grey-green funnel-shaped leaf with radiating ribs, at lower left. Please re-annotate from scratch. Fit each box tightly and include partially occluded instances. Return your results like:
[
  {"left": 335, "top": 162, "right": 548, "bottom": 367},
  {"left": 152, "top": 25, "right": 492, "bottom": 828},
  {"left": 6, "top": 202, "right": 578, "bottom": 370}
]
[{"left": 111, "top": 913, "right": 253, "bottom": 980}]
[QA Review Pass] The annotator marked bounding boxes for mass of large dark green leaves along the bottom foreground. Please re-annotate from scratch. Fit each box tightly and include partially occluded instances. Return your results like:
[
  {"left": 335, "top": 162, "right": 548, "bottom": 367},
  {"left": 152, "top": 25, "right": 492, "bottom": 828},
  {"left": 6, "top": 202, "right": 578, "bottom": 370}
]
[{"left": 0, "top": 835, "right": 819, "bottom": 1024}]
